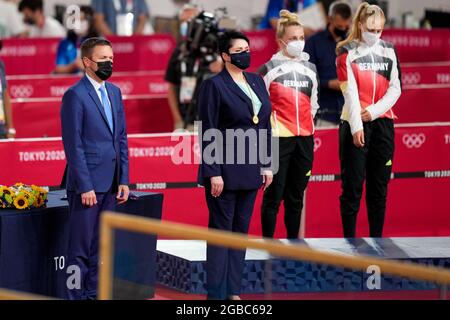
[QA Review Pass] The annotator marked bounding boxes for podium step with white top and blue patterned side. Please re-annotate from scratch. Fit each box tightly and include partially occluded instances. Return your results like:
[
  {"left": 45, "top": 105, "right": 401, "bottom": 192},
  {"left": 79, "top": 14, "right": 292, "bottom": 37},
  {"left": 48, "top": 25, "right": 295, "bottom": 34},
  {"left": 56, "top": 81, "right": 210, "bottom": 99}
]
[{"left": 157, "top": 237, "right": 450, "bottom": 294}]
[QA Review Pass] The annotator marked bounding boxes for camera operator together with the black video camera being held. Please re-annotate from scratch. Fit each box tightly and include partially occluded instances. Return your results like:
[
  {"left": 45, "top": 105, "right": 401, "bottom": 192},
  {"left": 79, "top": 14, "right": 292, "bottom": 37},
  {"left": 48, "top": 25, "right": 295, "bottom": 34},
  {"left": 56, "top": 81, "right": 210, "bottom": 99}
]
[{"left": 165, "top": 5, "right": 223, "bottom": 130}]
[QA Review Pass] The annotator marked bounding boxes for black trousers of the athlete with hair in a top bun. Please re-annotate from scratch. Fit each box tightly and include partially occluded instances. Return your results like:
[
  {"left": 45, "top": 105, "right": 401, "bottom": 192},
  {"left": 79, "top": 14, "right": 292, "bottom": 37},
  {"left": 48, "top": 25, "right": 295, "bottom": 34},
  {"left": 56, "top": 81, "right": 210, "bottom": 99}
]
[{"left": 261, "top": 136, "right": 314, "bottom": 239}]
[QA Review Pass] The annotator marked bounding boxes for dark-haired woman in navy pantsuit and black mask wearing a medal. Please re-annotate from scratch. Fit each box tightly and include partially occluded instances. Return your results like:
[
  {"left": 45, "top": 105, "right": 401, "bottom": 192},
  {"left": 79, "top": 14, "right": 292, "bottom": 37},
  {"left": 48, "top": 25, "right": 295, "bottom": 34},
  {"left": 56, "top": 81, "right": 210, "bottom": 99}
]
[{"left": 198, "top": 31, "right": 272, "bottom": 299}]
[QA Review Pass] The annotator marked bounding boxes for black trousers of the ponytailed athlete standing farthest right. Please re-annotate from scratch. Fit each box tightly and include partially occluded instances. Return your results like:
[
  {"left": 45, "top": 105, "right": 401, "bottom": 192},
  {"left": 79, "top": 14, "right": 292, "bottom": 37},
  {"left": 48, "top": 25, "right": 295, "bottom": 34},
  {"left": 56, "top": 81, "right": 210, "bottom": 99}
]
[{"left": 339, "top": 118, "right": 394, "bottom": 238}]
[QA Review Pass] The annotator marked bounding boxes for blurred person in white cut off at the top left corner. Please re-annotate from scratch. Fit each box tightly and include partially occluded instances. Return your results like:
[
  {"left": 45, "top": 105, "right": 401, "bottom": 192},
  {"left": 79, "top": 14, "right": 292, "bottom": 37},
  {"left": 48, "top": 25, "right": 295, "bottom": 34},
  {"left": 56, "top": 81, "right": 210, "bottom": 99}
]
[{"left": 0, "top": 0, "right": 27, "bottom": 39}]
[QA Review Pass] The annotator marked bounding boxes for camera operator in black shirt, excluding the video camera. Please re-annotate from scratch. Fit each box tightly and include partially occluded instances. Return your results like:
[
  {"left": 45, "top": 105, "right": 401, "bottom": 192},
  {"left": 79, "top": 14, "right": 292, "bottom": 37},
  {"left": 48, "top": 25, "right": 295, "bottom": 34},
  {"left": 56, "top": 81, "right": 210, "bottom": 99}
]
[{"left": 165, "top": 4, "right": 223, "bottom": 129}]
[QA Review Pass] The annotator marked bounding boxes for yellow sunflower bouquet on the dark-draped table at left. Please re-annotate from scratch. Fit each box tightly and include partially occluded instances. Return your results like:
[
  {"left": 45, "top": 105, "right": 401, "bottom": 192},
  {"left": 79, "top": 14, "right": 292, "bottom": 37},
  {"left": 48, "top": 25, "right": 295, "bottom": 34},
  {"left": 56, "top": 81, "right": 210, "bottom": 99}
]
[{"left": 0, "top": 183, "right": 48, "bottom": 210}]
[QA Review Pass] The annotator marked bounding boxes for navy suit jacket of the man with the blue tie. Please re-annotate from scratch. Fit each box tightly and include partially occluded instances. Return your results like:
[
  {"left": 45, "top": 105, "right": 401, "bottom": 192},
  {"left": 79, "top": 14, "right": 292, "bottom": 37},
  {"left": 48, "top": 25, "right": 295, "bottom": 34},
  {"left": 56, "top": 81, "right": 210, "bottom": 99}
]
[{"left": 61, "top": 76, "right": 129, "bottom": 193}]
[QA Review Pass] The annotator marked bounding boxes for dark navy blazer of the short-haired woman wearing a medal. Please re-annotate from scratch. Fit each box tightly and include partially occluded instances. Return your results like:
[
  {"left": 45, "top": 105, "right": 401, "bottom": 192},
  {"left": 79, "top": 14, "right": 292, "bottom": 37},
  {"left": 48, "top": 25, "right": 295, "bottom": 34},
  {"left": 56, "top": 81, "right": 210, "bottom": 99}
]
[{"left": 197, "top": 68, "right": 272, "bottom": 190}]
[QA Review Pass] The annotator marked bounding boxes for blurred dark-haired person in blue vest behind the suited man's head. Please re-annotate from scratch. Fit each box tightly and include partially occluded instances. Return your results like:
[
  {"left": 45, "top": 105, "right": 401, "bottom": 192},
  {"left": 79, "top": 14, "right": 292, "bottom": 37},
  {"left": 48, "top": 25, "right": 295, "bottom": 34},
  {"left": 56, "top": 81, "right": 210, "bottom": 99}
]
[{"left": 54, "top": 6, "right": 98, "bottom": 73}]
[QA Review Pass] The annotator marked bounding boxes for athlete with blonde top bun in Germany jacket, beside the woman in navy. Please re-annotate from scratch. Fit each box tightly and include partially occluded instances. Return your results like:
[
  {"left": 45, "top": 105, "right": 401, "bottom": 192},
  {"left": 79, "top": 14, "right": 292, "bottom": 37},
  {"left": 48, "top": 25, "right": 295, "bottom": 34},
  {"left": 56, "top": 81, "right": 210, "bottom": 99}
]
[{"left": 260, "top": 10, "right": 319, "bottom": 239}]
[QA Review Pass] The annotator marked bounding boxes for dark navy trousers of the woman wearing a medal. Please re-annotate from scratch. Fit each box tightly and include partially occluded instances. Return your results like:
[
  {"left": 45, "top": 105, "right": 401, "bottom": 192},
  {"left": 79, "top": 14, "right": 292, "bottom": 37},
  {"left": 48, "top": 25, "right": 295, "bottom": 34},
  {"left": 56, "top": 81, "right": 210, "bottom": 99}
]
[{"left": 205, "top": 186, "right": 258, "bottom": 299}]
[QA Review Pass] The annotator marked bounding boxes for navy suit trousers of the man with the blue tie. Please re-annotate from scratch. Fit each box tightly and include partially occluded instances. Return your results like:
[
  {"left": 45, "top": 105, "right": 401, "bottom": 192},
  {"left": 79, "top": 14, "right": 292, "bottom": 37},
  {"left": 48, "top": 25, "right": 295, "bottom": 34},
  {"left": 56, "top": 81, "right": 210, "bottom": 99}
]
[{"left": 66, "top": 192, "right": 116, "bottom": 300}]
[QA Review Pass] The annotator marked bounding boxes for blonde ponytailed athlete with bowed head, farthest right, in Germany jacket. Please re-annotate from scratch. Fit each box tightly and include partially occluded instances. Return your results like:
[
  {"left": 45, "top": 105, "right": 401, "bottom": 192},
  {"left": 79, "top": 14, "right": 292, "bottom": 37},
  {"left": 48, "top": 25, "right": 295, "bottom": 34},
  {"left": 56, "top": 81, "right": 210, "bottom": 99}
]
[{"left": 336, "top": 2, "right": 401, "bottom": 238}]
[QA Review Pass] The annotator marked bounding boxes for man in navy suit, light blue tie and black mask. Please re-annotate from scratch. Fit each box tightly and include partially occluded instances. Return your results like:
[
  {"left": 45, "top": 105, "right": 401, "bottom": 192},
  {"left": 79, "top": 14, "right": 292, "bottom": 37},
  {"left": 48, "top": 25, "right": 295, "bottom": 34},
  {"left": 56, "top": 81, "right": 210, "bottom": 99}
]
[{"left": 61, "top": 38, "right": 129, "bottom": 299}]
